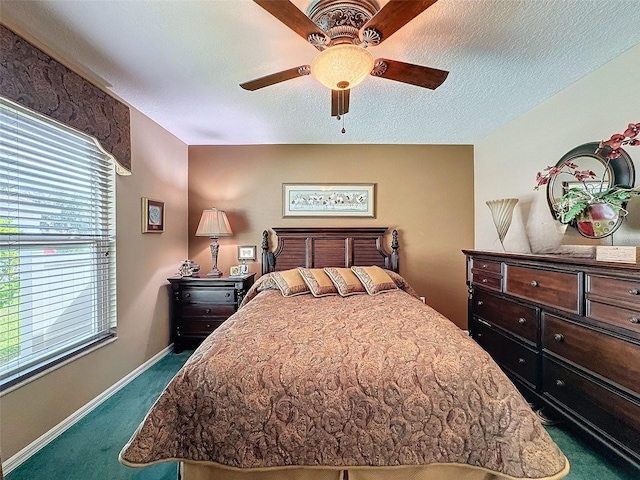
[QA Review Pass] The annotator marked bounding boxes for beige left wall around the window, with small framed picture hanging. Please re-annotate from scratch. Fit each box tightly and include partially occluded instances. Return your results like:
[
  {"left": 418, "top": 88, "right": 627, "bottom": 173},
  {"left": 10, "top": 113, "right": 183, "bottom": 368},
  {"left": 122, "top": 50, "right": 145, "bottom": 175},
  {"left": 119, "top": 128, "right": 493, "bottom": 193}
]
[{"left": 0, "top": 109, "right": 188, "bottom": 460}]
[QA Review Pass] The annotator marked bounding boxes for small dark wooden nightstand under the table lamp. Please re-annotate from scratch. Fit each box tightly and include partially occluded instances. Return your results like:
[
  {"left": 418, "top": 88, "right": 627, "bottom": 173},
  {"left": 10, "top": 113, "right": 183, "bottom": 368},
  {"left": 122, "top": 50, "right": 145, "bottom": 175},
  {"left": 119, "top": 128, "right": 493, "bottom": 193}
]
[{"left": 167, "top": 273, "right": 255, "bottom": 353}]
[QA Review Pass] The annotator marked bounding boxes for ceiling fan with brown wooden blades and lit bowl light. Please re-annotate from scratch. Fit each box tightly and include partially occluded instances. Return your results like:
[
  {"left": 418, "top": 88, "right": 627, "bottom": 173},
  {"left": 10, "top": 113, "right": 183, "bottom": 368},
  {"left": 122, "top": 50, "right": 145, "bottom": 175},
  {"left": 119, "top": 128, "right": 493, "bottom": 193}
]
[{"left": 240, "top": 0, "right": 449, "bottom": 129}]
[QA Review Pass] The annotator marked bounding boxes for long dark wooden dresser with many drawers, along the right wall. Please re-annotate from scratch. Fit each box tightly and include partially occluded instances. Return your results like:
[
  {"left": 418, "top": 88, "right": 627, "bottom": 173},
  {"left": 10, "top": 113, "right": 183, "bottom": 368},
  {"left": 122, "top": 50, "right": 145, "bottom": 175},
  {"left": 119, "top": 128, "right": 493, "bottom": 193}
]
[{"left": 463, "top": 250, "right": 640, "bottom": 468}]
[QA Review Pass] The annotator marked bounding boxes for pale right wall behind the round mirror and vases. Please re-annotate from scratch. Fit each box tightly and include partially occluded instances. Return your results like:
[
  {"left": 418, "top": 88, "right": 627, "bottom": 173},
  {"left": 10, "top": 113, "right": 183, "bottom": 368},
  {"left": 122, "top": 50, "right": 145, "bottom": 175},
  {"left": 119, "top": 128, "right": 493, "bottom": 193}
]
[{"left": 475, "top": 45, "right": 640, "bottom": 252}]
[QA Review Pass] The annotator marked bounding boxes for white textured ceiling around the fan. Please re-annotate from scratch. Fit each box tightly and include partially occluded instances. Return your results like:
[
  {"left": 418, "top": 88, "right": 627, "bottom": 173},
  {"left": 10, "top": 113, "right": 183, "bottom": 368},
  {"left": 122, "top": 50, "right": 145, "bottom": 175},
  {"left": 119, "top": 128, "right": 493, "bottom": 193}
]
[{"left": 0, "top": 0, "right": 640, "bottom": 145}]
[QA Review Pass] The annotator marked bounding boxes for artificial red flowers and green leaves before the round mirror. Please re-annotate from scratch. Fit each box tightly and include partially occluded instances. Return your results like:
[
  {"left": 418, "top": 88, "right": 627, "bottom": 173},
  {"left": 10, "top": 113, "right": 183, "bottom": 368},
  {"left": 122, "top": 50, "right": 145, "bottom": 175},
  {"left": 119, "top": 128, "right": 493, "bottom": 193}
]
[{"left": 535, "top": 123, "right": 640, "bottom": 223}]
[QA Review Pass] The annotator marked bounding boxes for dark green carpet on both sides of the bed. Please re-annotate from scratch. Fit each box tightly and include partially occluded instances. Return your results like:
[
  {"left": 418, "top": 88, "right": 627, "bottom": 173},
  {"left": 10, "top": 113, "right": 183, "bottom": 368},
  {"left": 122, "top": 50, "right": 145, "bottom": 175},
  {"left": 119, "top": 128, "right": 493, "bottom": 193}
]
[{"left": 5, "top": 352, "right": 640, "bottom": 480}]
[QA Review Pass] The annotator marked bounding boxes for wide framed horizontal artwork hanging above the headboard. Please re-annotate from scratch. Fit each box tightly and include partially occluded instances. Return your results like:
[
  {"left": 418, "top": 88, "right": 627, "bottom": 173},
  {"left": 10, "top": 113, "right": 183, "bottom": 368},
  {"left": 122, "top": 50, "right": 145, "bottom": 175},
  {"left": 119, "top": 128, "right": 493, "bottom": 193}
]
[{"left": 282, "top": 183, "right": 376, "bottom": 218}]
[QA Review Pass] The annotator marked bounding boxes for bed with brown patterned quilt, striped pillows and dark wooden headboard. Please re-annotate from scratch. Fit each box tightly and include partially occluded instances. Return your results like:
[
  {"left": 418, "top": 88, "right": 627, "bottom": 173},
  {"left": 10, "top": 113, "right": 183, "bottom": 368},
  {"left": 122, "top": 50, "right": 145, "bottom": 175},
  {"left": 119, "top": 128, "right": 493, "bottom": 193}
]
[{"left": 120, "top": 227, "right": 569, "bottom": 480}]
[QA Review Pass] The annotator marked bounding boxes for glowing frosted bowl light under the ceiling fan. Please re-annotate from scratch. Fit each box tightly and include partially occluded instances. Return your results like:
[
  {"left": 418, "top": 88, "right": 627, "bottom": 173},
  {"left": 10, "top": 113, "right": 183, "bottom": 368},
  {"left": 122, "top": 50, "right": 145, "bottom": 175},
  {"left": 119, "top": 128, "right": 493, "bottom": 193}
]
[{"left": 311, "top": 44, "right": 374, "bottom": 90}]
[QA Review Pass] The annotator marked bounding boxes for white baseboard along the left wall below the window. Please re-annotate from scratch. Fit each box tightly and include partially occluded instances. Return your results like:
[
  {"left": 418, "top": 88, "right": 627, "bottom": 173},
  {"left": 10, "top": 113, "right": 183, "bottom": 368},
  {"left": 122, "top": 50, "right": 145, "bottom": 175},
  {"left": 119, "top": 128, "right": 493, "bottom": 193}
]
[{"left": 2, "top": 344, "right": 173, "bottom": 475}]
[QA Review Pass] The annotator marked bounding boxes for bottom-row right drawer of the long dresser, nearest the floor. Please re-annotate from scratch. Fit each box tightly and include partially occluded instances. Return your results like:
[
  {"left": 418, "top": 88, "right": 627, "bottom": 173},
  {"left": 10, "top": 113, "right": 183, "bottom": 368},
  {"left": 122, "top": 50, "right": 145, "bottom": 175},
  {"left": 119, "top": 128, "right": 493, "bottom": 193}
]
[{"left": 542, "top": 356, "right": 640, "bottom": 455}]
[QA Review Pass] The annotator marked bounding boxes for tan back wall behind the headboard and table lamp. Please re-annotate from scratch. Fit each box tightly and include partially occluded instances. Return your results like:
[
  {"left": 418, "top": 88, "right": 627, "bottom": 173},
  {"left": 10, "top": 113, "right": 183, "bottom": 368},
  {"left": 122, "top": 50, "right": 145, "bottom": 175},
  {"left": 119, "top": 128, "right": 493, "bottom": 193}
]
[{"left": 189, "top": 145, "right": 473, "bottom": 328}]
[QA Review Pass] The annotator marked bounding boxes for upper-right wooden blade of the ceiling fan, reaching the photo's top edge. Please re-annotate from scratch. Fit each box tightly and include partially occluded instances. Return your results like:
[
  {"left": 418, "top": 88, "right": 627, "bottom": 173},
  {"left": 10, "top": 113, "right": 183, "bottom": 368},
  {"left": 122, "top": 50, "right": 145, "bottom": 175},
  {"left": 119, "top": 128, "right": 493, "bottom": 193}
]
[{"left": 360, "top": 0, "right": 438, "bottom": 45}]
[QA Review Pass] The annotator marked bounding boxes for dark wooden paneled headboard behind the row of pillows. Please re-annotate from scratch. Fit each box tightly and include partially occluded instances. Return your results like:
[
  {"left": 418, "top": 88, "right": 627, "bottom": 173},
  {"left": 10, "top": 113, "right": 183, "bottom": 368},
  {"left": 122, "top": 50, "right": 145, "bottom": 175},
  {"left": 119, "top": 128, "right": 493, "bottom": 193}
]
[{"left": 262, "top": 227, "right": 399, "bottom": 275}]
